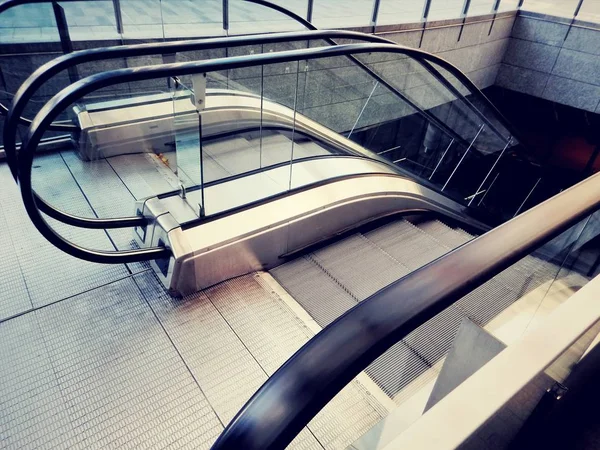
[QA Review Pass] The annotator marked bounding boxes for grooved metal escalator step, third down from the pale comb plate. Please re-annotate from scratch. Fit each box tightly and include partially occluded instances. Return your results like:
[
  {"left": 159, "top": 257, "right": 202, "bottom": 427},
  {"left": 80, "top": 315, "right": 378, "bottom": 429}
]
[{"left": 365, "top": 220, "right": 448, "bottom": 271}]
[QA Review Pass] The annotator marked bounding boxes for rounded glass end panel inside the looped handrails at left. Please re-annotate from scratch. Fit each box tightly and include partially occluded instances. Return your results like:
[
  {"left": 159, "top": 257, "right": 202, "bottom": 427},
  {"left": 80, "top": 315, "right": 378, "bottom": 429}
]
[{"left": 32, "top": 80, "right": 179, "bottom": 250}]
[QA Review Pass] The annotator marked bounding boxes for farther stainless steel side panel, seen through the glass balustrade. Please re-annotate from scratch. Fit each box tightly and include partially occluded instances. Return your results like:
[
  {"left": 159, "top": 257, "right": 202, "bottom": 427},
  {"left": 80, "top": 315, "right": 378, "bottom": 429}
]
[{"left": 78, "top": 89, "right": 385, "bottom": 162}]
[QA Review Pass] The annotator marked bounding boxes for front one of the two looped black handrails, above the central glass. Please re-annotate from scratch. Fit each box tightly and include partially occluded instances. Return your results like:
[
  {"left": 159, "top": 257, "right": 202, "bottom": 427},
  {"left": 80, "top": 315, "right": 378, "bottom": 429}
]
[{"left": 12, "top": 42, "right": 544, "bottom": 262}]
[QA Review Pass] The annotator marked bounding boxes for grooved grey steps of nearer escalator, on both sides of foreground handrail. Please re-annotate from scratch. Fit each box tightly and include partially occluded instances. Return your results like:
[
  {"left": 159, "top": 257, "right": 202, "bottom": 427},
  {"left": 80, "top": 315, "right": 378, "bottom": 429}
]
[{"left": 271, "top": 215, "right": 576, "bottom": 398}]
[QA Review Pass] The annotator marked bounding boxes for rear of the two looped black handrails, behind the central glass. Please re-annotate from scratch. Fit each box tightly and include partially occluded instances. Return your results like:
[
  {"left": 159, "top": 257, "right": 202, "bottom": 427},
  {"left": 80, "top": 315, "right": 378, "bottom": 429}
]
[{"left": 4, "top": 30, "right": 500, "bottom": 234}]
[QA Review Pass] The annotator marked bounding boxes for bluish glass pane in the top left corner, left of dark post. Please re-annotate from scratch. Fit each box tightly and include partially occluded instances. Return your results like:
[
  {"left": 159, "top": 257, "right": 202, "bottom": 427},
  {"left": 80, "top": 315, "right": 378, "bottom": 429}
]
[{"left": 0, "top": 3, "right": 59, "bottom": 44}]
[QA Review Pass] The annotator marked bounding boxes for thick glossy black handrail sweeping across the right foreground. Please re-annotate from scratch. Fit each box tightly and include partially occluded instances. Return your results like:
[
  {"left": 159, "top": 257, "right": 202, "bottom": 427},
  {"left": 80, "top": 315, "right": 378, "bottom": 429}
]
[{"left": 212, "top": 174, "right": 600, "bottom": 450}]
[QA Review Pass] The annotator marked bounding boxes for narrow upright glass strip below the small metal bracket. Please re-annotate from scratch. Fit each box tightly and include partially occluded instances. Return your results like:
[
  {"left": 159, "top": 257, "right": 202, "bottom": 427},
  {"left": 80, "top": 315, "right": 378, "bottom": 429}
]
[{"left": 171, "top": 78, "right": 204, "bottom": 217}]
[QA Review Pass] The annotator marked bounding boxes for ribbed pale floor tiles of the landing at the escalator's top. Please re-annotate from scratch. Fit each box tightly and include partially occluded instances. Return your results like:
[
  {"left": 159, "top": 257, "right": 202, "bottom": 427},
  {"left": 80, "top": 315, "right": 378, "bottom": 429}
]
[{"left": 0, "top": 160, "right": 384, "bottom": 449}]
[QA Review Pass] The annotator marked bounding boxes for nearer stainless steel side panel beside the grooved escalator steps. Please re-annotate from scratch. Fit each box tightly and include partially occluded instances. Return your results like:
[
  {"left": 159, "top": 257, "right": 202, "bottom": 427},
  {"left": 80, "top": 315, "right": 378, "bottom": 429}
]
[{"left": 165, "top": 175, "right": 476, "bottom": 295}]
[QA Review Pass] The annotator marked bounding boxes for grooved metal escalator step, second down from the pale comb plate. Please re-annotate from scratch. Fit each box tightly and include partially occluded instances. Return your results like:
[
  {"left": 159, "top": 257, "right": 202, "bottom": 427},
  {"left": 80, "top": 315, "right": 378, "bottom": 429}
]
[{"left": 309, "top": 234, "right": 409, "bottom": 301}]
